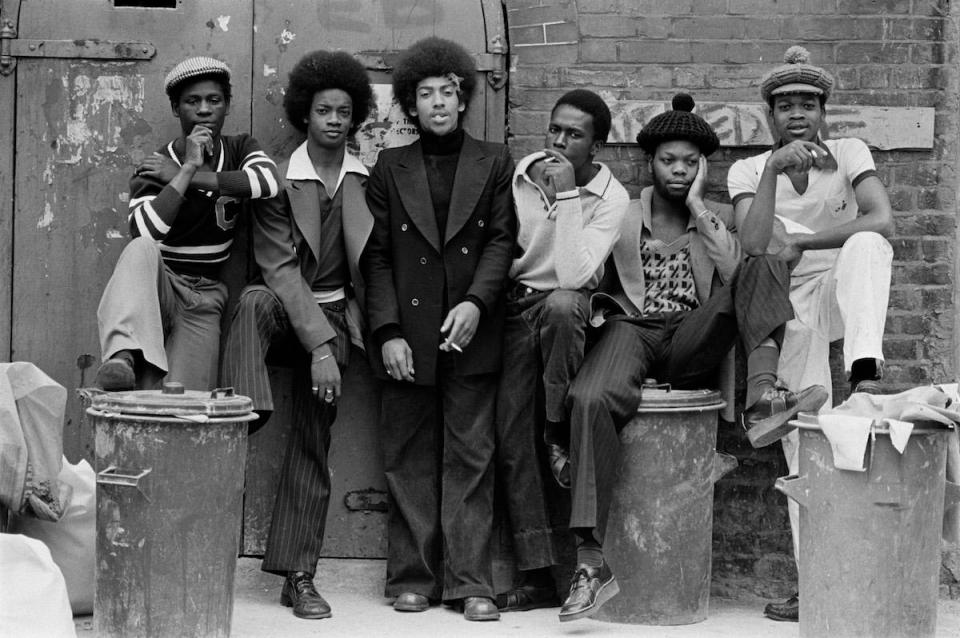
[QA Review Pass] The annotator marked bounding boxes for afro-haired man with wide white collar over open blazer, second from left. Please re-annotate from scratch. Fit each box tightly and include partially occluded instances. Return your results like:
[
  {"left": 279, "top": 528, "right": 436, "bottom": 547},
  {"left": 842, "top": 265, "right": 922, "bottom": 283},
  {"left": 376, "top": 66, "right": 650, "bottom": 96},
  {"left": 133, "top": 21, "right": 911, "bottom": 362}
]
[{"left": 221, "top": 51, "right": 373, "bottom": 618}]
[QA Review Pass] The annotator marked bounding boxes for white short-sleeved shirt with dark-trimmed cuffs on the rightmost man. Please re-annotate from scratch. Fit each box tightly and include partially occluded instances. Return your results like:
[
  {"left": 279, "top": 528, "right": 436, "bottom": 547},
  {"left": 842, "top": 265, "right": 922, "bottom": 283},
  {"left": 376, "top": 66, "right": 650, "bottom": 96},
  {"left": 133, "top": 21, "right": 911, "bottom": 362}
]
[{"left": 727, "top": 137, "right": 877, "bottom": 232}]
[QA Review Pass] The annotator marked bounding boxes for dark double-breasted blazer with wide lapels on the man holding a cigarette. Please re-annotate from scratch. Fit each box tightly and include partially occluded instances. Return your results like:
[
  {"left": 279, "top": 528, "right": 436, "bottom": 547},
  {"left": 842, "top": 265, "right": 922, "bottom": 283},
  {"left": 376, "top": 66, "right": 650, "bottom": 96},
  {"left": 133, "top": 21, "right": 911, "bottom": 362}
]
[{"left": 360, "top": 135, "right": 517, "bottom": 385}]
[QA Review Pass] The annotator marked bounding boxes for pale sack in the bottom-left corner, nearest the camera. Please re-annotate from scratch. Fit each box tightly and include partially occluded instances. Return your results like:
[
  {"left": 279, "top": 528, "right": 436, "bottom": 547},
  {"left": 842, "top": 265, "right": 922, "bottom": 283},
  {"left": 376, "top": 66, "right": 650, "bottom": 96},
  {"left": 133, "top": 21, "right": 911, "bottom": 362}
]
[{"left": 0, "top": 534, "right": 77, "bottom": 638}]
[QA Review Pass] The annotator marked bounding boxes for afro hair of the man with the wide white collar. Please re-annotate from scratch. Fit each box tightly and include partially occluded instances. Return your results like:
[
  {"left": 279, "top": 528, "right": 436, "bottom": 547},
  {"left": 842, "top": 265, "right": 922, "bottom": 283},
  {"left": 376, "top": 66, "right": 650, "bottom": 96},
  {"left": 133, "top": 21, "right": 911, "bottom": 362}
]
[{"left": 283, "top": 51, "right": 373, "bottom": 135}]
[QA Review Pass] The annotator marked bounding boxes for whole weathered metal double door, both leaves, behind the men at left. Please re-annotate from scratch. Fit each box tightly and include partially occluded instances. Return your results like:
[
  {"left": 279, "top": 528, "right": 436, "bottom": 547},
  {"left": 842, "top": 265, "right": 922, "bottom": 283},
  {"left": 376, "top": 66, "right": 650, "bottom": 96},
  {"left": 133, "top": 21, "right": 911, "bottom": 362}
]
[{"left": 0, "top": 0, "right": 507, "bottom": 556}]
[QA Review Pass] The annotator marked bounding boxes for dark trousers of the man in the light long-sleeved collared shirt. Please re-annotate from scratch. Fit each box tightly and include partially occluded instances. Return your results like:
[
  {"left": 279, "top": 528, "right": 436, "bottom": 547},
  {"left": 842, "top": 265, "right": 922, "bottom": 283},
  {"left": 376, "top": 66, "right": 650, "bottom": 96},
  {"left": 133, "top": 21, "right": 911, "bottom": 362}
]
[{"left": 496, "top": 290, "right": 589, "bottom": 570}]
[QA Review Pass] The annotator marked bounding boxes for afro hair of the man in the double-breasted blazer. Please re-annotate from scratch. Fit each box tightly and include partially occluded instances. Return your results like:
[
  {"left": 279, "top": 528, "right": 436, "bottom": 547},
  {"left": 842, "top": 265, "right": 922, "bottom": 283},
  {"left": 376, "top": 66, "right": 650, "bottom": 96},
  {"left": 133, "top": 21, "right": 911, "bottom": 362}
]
[{"left": 393, "top": 37, "right": 477, "bottom": 114}]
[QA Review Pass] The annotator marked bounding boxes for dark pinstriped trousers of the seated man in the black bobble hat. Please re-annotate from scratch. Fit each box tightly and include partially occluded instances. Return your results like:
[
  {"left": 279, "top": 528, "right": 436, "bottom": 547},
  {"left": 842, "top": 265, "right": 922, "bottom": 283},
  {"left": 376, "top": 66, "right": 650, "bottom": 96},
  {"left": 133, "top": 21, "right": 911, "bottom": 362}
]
[{"left": 568, "top": 256, "right": 793, "bottom": 543}]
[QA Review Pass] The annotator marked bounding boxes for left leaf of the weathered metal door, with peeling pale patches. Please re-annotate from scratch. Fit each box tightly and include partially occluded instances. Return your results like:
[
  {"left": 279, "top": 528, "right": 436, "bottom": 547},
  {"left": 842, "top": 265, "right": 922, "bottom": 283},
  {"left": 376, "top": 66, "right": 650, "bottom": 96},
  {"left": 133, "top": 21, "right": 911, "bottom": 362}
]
[{"left": 0, "top": 0, "right": 253, "bottom": 460}]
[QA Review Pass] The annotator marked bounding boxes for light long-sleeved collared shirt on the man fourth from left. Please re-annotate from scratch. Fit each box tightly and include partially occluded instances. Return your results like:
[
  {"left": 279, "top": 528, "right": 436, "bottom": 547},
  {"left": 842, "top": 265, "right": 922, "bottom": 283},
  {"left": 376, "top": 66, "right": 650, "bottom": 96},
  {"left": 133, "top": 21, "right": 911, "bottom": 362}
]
[{"left": 510, "top": 151, "right": 630, "bottom": 290}]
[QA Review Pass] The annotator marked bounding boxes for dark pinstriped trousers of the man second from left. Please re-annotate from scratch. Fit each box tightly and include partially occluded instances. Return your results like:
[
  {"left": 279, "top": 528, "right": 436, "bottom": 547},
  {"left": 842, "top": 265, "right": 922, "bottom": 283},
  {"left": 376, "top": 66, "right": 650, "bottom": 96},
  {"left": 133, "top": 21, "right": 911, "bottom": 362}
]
[{"left": 221, "top": 286, "right": 350, "bottom": 574}]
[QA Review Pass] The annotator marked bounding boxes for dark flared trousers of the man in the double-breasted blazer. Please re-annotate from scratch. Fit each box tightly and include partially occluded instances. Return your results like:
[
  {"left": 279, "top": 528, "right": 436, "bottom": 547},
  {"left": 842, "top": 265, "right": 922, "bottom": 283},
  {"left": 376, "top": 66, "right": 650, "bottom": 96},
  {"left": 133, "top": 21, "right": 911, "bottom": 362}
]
[{"left": 380, "top": 362, "right": 497, "bottom": 600}]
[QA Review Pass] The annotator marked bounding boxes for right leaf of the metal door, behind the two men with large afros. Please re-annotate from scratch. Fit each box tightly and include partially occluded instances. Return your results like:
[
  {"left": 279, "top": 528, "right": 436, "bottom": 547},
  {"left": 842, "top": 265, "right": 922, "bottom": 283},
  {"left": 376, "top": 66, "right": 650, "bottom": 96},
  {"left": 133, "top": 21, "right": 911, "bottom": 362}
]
[{"left": 243, "top": 0, "right": 507, "bottom": 557}]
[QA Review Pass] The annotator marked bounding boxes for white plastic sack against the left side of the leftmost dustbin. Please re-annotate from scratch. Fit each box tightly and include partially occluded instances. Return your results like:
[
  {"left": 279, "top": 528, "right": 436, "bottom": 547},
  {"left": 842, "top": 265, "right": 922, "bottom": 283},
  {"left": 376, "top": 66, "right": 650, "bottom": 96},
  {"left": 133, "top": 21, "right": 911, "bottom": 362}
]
[{"left": 10, "top": 457, "right": 97, "bottom": 615}]
